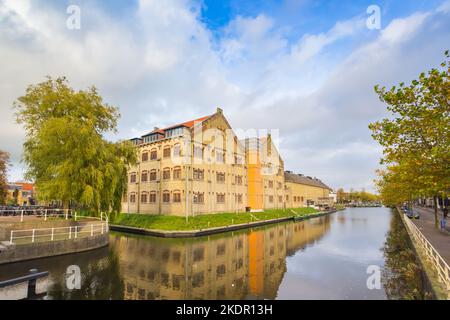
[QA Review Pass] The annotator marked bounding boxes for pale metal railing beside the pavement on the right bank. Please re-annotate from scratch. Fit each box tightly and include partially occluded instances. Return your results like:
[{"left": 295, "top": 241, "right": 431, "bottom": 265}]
[{"left": 403, "top": 214, "right": 450, "bottom": 299}]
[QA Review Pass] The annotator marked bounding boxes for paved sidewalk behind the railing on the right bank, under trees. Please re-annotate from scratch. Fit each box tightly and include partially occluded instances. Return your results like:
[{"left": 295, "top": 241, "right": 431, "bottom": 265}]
[{"left": 412, "top": 207, "right": 450, "bottom": 265}]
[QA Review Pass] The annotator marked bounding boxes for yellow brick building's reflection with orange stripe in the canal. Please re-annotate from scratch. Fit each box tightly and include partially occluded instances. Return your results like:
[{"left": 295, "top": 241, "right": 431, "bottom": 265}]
[{"left": 110, "top": 216, "right": 330, "bottom": 300}]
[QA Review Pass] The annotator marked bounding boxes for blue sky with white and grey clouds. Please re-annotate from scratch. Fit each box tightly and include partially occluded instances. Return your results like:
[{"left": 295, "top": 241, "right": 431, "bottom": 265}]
[{"left": 0, "top": 0, "right": 450, "bottom": 191}]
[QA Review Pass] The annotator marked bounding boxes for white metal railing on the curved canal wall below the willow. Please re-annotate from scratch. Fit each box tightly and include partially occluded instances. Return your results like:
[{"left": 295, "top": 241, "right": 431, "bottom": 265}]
[{"left": 9, "top": 220, "right": 109, "bottom": 244}]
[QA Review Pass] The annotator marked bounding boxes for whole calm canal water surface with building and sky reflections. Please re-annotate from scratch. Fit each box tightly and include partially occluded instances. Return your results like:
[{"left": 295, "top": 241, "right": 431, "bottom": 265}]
[{"left": 0, "top": 208, "right": 430, "bottom": 299}]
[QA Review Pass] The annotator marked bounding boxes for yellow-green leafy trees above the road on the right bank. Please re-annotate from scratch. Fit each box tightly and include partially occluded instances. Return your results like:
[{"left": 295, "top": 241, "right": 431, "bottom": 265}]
[{"left": 369, "top": 51, "right": 450, "bottom": 226}]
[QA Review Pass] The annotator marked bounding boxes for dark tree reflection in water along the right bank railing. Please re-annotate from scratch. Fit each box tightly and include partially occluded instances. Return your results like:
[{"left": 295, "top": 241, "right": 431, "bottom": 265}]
[{"left": 383, "top": 212, "right": 432, "bottom": 300}]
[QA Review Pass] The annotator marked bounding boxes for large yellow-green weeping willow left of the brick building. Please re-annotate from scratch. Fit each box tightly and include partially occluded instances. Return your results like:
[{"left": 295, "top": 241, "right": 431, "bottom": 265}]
[{"left": 14, "top": 78, "right": 136, "bottom": 213}]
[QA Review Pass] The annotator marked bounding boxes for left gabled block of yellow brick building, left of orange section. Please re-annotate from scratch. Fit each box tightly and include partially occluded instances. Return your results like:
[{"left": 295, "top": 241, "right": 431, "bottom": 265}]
[{"left": 122, "top": 108, "right": 248, "bottom": 216}]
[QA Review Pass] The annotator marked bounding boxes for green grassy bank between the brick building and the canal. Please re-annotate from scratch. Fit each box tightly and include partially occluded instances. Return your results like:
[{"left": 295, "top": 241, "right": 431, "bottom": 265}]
[{"left": 110, "top": 208, "right": 318, "bottom": 231}]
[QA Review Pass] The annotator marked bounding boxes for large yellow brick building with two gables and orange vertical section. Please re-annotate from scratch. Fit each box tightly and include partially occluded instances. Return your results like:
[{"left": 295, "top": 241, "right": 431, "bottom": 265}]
[{"left": 122, "top": 108, "right": 329, "bottom": 216}]
